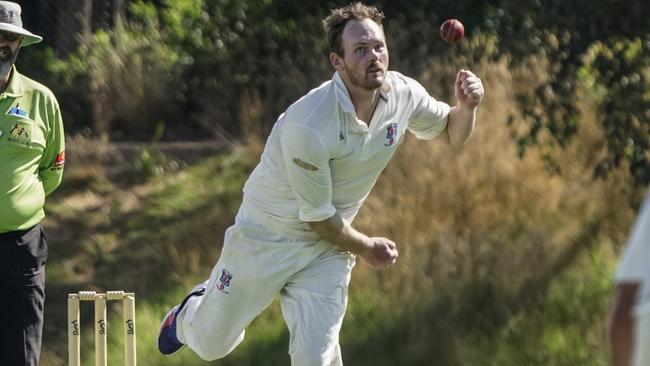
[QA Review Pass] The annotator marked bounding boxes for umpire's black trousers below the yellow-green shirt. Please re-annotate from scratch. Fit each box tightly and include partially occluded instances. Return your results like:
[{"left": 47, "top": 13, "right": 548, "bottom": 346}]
[{"left": 0, "top": 225, "right": 47, "bottom": 366}]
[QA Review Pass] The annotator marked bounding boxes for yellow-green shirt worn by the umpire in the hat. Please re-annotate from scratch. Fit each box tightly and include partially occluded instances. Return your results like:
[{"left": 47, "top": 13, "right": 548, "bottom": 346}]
[{"left": 0, "top": 67, "right": 65, "bottom": 233}]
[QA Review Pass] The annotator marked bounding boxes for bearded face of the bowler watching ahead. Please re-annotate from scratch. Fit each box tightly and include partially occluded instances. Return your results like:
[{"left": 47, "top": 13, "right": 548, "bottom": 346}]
[{"left": 335, "top": 19, "right": 388, "bottom": 90}]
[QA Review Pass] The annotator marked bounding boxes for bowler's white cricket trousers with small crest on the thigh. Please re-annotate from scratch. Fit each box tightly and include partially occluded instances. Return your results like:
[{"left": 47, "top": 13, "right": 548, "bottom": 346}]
[{"left": 177, "top": 209, "right": 355, "bottom": 366}]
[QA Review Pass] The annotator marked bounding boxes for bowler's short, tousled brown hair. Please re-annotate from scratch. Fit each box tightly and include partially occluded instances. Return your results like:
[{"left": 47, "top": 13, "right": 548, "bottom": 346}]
[{"left": 323, "top": 3, "right": 384, "bottom": 56}]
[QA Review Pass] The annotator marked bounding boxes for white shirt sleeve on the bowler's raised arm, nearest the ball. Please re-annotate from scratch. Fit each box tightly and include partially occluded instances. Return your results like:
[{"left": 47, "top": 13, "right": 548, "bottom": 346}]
[{"left": 408, "top": 79, "right": 450, "bottom": 140}]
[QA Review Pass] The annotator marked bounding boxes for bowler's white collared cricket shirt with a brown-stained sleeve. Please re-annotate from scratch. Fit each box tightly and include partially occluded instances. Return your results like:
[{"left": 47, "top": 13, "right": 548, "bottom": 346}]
[{"left": 243, "top": 71, "right": 450, "bottom": 239}]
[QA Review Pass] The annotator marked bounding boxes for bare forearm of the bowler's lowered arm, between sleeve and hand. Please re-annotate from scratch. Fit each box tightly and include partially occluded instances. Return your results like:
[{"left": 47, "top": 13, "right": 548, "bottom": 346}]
[{"left": 308, "top": 214, "right": 372, "bottom": 255}]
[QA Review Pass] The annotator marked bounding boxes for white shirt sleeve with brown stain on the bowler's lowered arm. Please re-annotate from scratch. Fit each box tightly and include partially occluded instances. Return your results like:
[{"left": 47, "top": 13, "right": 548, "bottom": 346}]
[{"left": 279, "top": 123, "right": 336, "bottom": 222}]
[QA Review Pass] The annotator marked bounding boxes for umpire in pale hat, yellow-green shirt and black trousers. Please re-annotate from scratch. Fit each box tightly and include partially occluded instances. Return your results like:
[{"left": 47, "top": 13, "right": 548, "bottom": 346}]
[{"left": 0, "top": 1, "right": 65, "bottom": 366}]
